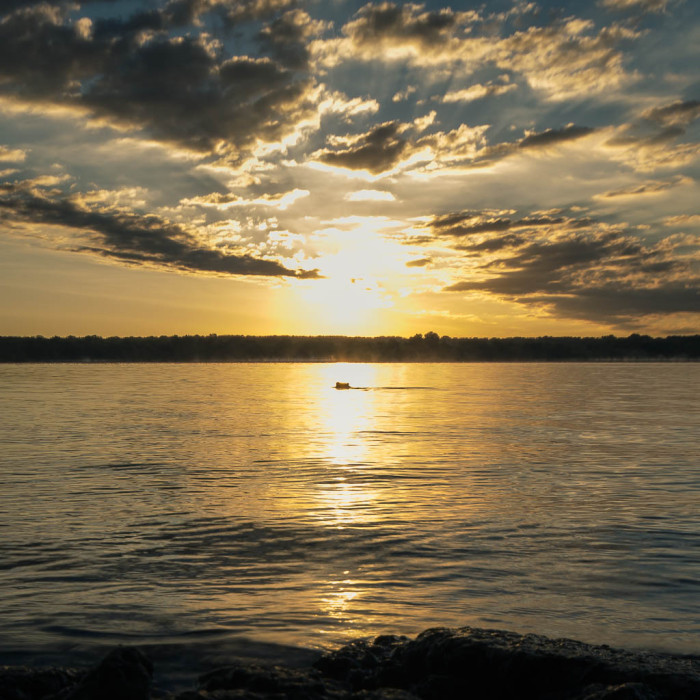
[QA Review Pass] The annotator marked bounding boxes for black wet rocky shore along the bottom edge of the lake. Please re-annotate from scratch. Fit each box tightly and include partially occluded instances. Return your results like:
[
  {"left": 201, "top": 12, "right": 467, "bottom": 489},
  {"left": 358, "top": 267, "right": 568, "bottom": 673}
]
[{"left": 0, "top": 627, "right": 700, "bottom": 700}]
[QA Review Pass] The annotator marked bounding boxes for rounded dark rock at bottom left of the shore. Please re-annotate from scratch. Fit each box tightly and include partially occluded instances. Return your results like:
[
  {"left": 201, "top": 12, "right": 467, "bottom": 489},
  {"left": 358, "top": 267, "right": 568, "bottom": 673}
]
[{"left": 52, "top": 647, "right": 153, "bottom": 700}]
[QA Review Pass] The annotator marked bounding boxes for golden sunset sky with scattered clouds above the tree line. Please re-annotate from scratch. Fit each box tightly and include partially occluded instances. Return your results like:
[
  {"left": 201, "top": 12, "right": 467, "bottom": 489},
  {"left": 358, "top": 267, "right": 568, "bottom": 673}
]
[{"left": 0, "top": 0, "right": 700, "bottom": 337}]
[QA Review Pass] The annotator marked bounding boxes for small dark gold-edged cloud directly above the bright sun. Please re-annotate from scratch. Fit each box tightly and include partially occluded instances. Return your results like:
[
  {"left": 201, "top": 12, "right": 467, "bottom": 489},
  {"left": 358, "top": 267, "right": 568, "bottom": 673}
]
[{"left": 314, "top": 121, "right": 408, "bottom": 174}]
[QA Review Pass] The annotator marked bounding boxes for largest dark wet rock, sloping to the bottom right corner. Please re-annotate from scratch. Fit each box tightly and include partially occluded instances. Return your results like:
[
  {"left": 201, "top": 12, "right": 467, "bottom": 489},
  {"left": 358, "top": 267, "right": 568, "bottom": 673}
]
[{"left": 316, "top": 627, "right": 700, "bottom": 700}]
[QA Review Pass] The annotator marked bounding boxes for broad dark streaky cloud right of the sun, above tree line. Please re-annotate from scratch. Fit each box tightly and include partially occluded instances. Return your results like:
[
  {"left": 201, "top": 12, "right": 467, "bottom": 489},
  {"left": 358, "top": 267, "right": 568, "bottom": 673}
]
[{"left": 446, "top": 211, "right": 700, "bottom": 321}]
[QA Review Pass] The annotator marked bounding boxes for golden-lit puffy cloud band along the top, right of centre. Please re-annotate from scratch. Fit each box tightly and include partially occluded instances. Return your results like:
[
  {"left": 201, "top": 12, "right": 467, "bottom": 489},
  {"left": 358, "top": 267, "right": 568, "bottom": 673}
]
[{"left": 310, "top": 2, "right": 640, "bottom": 101}]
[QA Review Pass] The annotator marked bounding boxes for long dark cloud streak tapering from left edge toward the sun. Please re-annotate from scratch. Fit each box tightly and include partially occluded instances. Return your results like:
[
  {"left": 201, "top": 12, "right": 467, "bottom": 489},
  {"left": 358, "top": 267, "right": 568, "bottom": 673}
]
[{"left": 0, "top": 183, "right": 318, "bottom": 278}]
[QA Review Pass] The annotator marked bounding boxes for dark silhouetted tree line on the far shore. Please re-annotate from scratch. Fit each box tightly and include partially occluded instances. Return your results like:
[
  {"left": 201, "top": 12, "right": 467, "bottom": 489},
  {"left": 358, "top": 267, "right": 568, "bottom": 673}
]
[{"left": 0, "top": 332, "right": 700, "bottom": 362}]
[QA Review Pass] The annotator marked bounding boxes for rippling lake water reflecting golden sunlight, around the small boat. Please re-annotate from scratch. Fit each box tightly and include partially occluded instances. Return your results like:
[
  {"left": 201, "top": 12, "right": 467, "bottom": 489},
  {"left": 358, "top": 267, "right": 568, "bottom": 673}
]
[{"left": 0, "top": 364, "right": 700, "bottom": 672}]
